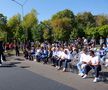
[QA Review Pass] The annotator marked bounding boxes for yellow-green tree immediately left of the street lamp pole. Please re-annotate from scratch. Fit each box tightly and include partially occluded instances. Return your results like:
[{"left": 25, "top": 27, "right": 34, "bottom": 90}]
[{"left": 7, "top": 14, "right": 24, "bottom": 40}]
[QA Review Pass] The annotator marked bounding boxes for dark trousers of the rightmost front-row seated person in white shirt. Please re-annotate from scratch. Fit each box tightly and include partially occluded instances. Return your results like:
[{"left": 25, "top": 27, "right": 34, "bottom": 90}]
[{"left": 85, "top": 65, "right": 101, "bottom": 77}]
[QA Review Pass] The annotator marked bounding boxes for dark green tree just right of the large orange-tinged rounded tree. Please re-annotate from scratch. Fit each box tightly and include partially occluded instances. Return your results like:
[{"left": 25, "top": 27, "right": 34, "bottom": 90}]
[{"left": 76, "top": 12, "right": 96, "bottom": 37}]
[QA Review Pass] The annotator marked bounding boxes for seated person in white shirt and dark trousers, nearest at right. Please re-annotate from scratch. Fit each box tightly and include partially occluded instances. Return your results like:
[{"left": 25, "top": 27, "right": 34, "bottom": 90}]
[{"left": 83, "top": 51, "right": 101, "bottom": 82}]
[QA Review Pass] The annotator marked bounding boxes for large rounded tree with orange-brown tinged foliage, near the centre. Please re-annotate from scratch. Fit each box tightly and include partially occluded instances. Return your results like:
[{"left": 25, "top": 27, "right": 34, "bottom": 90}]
[{"left": 51, "top": 9, "right": 75, "bottom": 41}]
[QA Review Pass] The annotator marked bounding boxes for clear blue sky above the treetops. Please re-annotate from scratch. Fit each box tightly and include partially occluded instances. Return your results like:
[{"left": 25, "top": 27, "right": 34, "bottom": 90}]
[{"left": 0, "top": 0, "right": 108, "bottom": 21}]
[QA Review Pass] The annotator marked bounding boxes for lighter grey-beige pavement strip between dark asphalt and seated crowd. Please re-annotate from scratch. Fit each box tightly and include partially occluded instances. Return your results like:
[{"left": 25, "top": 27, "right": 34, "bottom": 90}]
[{"left": 5, "top": 56, "right": 108, "bottom": 90}]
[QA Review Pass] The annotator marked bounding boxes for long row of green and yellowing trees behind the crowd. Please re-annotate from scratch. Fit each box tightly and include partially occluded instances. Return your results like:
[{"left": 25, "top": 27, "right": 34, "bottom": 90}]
[{"left": 0, "top": 9, "right": 108, "bottom": 42}]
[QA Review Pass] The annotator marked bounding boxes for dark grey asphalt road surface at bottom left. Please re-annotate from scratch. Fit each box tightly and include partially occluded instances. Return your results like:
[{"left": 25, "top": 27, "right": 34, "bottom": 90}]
[{"left": 0, "top": 66, "right": 76, "bottom": 90}]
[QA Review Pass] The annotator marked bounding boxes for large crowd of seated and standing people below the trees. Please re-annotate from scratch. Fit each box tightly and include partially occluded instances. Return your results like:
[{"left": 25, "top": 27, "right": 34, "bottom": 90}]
[{"left": 0, "top": 37, "right": 108, "bottom": 82}]
